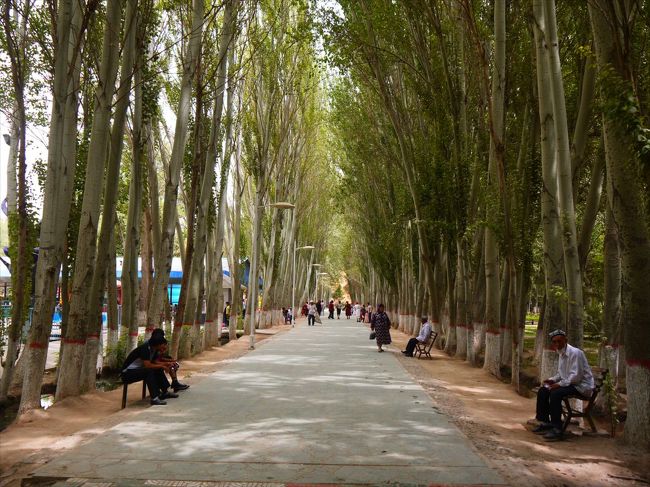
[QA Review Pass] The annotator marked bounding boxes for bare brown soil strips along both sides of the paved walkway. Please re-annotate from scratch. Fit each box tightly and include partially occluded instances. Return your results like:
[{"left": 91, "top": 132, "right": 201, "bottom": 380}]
[{"left": 0, "top": 320, "right": 650, "bottom": 487}]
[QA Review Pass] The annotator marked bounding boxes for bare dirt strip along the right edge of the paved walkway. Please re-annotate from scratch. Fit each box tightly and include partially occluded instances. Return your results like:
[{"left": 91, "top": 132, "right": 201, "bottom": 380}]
[{"left": 384, "top": 330, "right": 650, "bottom": 487}]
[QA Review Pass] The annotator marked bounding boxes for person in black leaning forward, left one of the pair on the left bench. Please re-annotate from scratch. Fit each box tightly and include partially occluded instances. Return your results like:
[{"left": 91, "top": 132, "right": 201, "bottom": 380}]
[{"left": 121, "top": 336, "right": 178, "bottom": 406}]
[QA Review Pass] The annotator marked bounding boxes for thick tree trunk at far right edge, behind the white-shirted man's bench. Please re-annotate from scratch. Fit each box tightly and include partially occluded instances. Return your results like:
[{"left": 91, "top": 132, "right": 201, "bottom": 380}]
[{"left": 589, "top": 0, "right": 650, "bottom": 449}]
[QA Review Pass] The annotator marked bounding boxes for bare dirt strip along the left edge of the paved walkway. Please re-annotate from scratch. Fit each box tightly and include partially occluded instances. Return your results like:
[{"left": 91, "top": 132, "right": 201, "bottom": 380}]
[{"left": 0, "top": 325, "right": 291, "bottom": 487}]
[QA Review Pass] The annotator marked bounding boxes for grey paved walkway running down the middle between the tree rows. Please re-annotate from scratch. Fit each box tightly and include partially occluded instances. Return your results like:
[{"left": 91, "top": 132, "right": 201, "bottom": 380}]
[{"left": 35, "top": 319, "right": 503, "bottom": 486}]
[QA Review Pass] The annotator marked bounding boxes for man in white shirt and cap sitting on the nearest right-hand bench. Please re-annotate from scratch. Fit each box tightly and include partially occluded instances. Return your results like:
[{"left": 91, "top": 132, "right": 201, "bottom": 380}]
[{"left": 533, "top": 330, "right": 594, "bottom": 441}]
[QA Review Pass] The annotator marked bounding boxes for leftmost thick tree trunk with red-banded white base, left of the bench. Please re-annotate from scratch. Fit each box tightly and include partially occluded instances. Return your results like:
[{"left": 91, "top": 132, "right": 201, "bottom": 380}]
[{"left": 19, "top": 0, "right": 84, "bottom": 414}]
